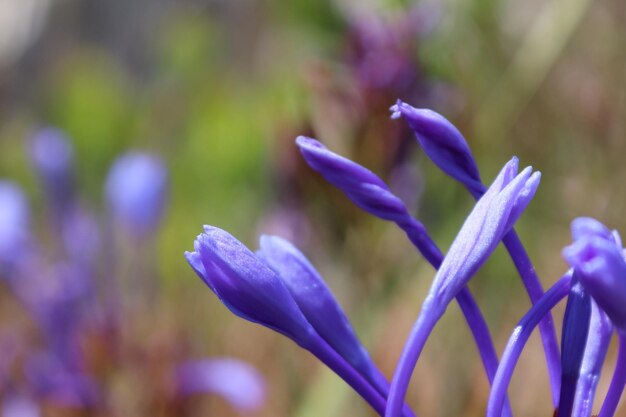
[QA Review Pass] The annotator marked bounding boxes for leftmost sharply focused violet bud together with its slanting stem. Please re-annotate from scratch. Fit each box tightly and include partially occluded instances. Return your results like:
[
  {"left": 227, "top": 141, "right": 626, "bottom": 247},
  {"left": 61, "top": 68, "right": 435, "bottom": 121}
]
[{"left": 185, "top": 226, "right": 413, "bottom": 417}]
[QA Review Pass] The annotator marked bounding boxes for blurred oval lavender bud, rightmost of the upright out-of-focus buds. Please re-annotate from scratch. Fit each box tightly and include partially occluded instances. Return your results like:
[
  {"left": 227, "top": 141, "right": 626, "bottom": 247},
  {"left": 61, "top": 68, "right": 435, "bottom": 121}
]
[{"left": 106, "top": 152, "right": 167, "bottom": 235}]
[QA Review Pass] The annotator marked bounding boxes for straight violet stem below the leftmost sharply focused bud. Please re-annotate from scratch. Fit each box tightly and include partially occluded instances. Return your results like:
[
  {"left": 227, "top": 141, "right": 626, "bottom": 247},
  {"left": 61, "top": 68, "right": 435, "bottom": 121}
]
[{"left": 306, "top": 336, "right": 415, "bottom": 417}]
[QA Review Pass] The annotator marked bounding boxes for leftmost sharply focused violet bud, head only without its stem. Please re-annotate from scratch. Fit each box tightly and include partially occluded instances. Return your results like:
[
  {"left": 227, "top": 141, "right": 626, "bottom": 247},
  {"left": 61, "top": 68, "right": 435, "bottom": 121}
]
[{"left": 185, "top": 226, "right": 314, "bottom": 347}]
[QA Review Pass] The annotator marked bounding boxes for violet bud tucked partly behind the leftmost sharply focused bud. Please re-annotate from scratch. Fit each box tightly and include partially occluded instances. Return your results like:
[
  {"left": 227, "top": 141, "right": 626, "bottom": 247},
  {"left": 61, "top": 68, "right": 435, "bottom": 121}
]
[{"left": 257, "top": 236, "right": 387, "bottom": 385}]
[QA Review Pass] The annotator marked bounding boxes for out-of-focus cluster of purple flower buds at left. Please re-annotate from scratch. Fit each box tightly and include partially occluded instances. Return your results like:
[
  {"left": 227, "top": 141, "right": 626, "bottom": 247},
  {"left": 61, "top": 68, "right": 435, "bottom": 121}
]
[{"left": 0, "top": 129, "right": 264, "bottom": 417}]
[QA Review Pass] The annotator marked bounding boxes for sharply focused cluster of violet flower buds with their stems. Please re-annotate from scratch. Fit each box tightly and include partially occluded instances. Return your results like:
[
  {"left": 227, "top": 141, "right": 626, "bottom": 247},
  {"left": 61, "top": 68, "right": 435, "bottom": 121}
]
[{"left": 186, "top": 101, "right": 626, "bottom": 417}]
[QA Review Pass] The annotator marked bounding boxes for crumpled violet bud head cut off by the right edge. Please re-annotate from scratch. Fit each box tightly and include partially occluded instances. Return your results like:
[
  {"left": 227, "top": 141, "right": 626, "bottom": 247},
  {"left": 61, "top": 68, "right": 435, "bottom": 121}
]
[{"left": 563, "top": 229, "right": 626, "bottom": 329}]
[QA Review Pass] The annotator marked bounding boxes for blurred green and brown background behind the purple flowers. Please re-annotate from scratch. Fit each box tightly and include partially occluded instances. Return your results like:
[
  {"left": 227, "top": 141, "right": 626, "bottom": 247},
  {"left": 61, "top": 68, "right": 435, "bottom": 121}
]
[{"left": 0, "top": 0, "right": 626, "bottom": 417}]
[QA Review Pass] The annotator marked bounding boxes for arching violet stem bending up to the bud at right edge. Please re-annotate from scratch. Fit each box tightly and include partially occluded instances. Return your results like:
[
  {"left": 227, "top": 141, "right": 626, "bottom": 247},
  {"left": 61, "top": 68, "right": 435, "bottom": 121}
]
[{"left": 487, "top": 273, "right": 571, "bottom": 417}]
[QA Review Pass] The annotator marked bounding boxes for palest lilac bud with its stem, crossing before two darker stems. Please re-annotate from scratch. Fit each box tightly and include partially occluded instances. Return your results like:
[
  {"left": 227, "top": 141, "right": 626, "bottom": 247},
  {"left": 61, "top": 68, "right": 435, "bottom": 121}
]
[{"left": 385, "top": 158, "right": 540, "bottom": 417}]
